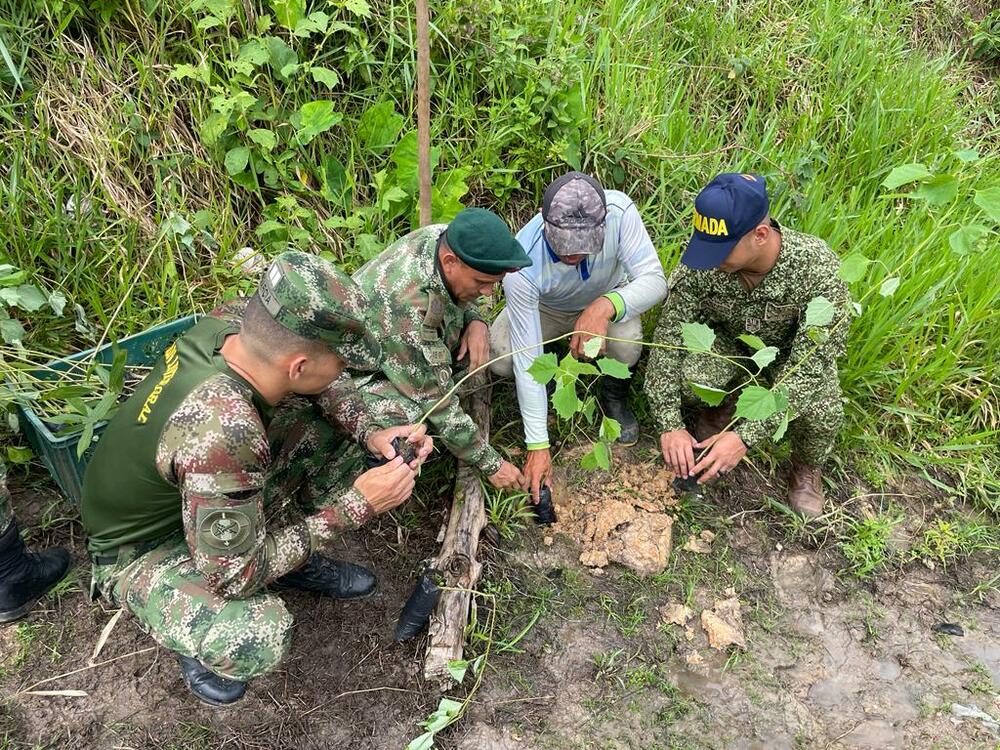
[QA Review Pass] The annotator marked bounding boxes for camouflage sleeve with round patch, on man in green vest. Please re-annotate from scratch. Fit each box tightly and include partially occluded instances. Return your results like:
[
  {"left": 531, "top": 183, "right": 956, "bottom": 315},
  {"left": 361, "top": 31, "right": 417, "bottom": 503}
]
[{"left": 162, "top": 375, "right": 371, "bottom": 599}]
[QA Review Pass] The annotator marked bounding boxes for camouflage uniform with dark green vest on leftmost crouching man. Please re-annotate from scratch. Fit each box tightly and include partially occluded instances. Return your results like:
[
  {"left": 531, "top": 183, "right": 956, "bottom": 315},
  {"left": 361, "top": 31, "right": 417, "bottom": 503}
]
[{"left": 82, "top": 251, "right": 377, "bottom": 681}]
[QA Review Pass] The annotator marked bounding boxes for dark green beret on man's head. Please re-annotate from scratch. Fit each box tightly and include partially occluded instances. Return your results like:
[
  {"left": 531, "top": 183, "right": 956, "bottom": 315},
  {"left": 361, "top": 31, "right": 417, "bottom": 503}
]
[{"left": 445, "top": 208, "right": 531, "bottom": 275}]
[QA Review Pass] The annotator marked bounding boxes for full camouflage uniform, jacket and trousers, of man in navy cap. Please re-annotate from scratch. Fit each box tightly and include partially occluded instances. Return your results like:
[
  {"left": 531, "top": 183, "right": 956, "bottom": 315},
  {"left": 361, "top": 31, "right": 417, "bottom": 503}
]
[{"left": 645, "top": 228, "right": 852, "bottom": 466}]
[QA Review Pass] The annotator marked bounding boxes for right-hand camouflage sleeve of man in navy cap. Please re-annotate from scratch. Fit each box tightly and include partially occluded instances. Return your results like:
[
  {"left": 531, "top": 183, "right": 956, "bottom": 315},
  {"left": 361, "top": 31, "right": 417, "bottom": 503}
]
[{"left": 735, "top": 256, "right": 853, "bottom": 448}]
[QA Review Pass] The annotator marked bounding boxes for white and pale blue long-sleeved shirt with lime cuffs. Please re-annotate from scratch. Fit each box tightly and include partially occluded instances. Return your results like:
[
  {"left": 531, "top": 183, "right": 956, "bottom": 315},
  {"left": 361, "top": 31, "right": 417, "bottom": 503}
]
[{"left": 503, "top": 190, "right": 667, "bottom": 449}]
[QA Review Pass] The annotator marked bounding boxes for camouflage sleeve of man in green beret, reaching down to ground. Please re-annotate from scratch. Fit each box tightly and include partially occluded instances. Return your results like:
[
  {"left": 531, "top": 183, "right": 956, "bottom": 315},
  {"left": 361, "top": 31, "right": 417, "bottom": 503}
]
[{"left": 382, "top": 301, "right": 503, "bottom": 476}]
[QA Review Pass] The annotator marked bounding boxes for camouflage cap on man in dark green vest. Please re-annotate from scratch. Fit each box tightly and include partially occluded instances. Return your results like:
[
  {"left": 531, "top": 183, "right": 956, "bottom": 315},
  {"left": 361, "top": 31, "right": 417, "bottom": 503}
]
[{"left": 257, "top": 252, "right": 382, "bottom": 371}]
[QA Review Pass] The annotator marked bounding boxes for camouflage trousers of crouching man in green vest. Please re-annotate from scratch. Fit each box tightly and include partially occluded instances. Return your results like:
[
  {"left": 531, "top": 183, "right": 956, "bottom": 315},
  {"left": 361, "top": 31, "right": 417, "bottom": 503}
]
[{"left": 93, "top": 399, "right": 364, "bottom": 681}]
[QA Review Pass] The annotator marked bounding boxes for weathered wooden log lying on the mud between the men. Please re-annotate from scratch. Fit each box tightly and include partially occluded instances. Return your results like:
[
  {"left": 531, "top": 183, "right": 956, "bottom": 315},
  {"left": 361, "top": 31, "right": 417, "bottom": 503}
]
[{"left": 424, "top": 373, "right": 492, "bottom": 680}]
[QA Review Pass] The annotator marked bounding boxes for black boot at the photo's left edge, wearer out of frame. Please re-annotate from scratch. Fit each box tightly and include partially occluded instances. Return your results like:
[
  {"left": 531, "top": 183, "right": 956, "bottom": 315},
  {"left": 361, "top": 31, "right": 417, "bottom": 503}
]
[{"left": 0, "top": 521, "right": 71, "bottom": 623}]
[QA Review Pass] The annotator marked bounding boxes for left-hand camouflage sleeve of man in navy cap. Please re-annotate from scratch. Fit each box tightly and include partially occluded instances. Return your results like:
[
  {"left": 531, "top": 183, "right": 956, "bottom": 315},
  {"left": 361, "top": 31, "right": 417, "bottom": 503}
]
[{"left": 643, "top": 266, "right": 702, "bottom": 434}]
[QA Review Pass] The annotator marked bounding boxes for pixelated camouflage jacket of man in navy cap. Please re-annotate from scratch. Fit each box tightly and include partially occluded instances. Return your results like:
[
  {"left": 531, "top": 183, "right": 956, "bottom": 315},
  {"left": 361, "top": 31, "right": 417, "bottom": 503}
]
[{"left": 645, "top": 223, "right": 853, "bottom": 447}]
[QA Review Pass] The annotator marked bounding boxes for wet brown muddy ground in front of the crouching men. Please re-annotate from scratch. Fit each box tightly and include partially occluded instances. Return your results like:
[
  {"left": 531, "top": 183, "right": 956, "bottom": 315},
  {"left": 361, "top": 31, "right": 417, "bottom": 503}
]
[{"left": 0, "top": 444, "right": 1000, "bottom": 750}]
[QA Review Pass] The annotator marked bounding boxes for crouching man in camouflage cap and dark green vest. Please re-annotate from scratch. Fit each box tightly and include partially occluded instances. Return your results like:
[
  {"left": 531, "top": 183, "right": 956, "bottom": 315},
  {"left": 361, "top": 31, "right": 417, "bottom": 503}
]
[{"left": 81, "top": 253, "right": 433, "bottom": 705}]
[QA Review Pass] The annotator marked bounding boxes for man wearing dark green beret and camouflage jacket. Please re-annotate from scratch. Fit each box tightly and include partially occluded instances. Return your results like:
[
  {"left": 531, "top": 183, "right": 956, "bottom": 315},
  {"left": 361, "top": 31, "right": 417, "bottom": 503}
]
[{"left": 353, "top": 208, "right": 531, "bottom": 489}]
